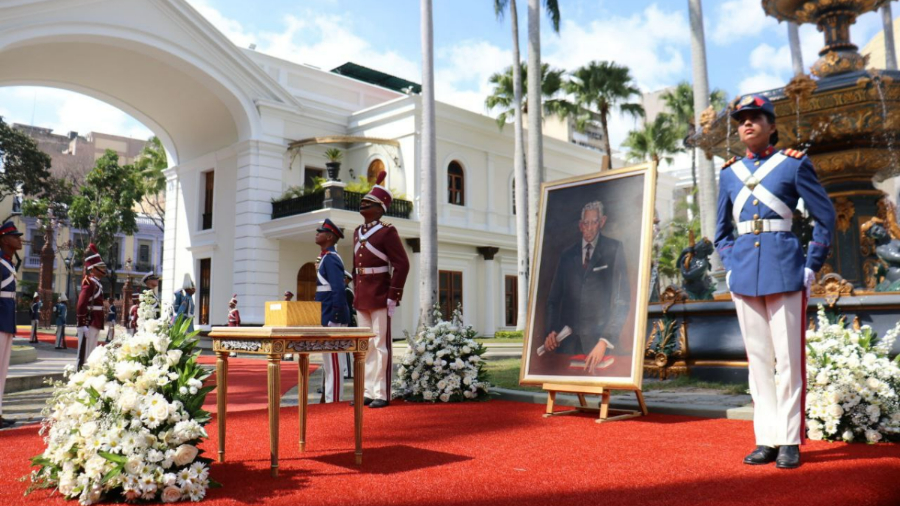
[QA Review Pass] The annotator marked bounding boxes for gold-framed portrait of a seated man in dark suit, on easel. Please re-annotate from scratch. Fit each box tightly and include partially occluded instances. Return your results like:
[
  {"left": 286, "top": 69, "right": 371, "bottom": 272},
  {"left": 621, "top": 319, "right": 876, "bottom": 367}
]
[{"left": 519, "top": 163, "right": 656, "bottom": 390}]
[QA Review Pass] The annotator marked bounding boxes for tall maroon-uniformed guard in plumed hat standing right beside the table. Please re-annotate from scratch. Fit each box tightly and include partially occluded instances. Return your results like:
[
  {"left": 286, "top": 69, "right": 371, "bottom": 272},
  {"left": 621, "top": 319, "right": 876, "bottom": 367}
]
[{"left": 353, "top": 172, "right": 409, "bottom": 408}]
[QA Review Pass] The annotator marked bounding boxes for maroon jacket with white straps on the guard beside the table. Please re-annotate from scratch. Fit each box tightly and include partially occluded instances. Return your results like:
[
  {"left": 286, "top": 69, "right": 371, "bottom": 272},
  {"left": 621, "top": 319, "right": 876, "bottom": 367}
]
[{"left": 353, "top": 221, "right": 409, "bottom": 311}]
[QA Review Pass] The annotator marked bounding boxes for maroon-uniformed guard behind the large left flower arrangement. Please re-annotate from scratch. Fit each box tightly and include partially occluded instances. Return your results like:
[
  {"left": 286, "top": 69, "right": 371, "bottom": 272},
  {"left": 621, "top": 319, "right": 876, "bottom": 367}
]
[{"left": 75, "top": 244, "right": 106, "bottom": 370}]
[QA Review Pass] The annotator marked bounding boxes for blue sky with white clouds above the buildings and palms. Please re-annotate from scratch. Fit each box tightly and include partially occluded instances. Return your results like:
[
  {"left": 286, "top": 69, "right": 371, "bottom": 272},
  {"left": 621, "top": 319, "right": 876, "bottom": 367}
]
[{"left": 0, "top": 0, "right": 881, "bottom": 150}]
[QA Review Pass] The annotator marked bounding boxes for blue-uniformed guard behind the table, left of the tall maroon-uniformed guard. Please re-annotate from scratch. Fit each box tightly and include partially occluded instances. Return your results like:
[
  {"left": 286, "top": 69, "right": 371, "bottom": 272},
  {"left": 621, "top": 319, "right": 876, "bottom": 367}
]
[{"left": 316, "top": 218, "right": 350, "bottom": 402}]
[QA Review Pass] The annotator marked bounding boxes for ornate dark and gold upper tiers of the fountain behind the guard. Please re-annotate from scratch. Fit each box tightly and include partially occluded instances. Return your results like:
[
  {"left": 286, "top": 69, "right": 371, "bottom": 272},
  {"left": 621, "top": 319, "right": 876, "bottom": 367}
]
[{"left": 696, "top": 0, "right": 900, "bottom": 290}]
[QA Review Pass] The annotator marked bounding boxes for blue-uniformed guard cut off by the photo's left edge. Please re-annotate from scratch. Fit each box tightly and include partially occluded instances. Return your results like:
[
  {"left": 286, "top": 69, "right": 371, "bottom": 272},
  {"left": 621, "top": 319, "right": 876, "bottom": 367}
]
[{"left": 0, "top": 221, "right": 22, "bottom": 429}]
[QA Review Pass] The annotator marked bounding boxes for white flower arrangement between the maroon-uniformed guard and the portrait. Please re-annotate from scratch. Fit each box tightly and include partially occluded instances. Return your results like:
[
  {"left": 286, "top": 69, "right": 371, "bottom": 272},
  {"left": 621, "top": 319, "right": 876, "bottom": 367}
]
[{"left": 394, "top": 308, "right": 490, "bottom": 402}]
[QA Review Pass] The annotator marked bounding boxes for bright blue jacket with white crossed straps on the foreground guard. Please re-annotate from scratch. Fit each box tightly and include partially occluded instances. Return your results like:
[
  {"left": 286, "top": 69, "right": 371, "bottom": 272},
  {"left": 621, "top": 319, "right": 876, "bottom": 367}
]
[{"left": 715, "top": 147, "right": 835, "bottom": 296}]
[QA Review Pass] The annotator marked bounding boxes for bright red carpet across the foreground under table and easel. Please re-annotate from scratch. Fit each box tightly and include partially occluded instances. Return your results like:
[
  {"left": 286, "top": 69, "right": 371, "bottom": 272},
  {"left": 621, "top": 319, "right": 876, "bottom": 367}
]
[{"left": 0, "top": 401, "right": 900, "bottom": 506}]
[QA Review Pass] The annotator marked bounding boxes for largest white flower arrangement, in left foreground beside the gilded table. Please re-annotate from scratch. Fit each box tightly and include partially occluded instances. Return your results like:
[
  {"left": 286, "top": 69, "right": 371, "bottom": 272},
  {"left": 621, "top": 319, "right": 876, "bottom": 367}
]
[{"left": 26, "top": 290, "right": 218, "bottom": 504}]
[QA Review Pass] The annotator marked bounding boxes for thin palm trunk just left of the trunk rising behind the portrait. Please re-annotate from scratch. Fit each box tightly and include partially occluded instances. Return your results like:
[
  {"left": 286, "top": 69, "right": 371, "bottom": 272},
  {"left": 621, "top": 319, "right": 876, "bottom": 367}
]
[{"left": 509, "top": 0, "right": 532, "bottom": 330}]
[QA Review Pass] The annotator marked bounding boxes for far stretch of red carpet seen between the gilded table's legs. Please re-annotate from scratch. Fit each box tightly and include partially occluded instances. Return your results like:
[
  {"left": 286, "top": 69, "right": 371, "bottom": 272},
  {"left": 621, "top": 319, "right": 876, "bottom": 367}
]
[{"left": 197, "top": 356, "right": 319, "bottom": 414}]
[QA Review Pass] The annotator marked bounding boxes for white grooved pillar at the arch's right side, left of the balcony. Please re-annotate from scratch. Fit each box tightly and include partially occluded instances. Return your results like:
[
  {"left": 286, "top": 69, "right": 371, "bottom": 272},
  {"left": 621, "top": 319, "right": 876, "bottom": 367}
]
[{"left": 233, "top": 141, "right": 285, "bottom": 324}]
